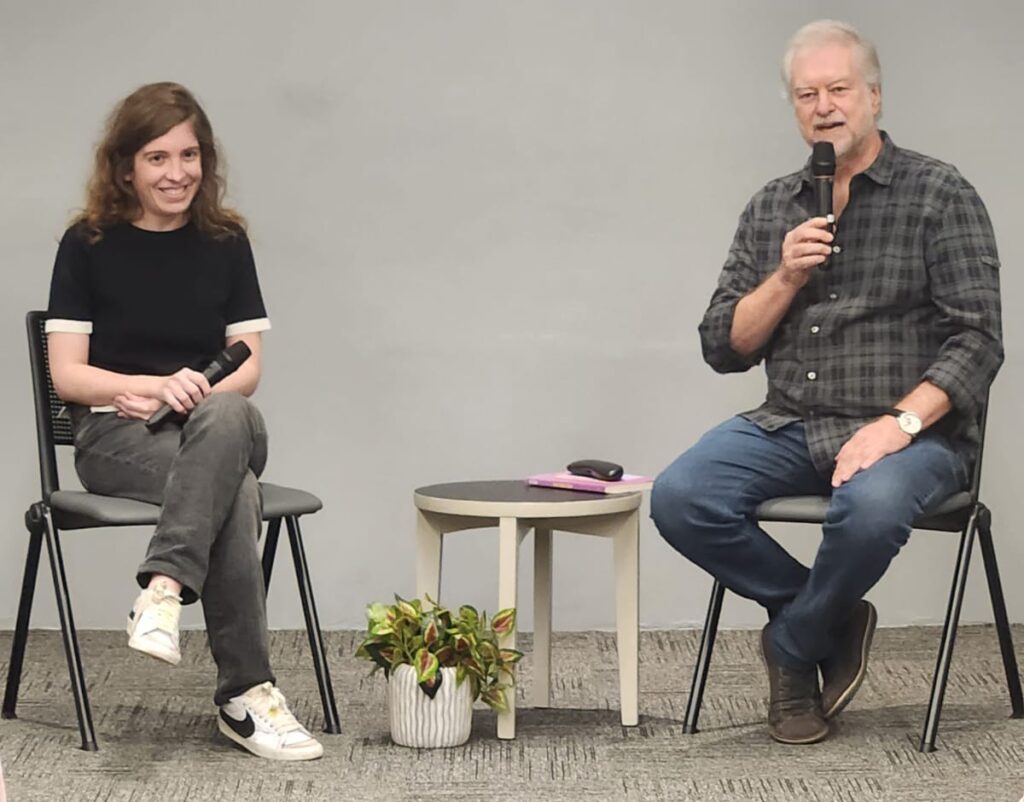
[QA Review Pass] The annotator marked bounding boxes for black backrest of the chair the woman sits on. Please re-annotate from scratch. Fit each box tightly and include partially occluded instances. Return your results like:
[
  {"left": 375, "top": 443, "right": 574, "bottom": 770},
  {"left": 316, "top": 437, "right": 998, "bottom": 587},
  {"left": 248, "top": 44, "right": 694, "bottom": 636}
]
[{"left": 25, "top": 311, "right": 75, "bottom": 504}]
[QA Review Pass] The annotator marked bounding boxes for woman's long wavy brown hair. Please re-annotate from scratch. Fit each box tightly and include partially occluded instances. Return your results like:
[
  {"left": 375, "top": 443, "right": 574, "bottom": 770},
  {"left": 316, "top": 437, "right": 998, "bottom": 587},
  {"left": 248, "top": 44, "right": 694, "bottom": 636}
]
[{"left": 73, "top": 82, "right": 246, "bottom": 242}]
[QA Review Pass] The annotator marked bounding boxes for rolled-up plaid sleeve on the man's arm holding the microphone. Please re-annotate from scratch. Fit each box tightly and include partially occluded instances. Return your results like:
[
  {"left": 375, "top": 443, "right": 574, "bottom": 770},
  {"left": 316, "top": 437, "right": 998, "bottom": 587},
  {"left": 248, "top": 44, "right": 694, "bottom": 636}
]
[{"left": 697, "top": 201, "right": 766, "bottom": 373}]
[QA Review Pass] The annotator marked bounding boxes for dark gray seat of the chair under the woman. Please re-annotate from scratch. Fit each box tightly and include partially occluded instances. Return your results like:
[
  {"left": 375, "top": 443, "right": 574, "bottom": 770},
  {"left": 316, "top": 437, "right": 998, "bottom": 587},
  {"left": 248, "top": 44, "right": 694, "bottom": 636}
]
[{"left": 50, "top": 482, "right": 324, "bottom": 530}]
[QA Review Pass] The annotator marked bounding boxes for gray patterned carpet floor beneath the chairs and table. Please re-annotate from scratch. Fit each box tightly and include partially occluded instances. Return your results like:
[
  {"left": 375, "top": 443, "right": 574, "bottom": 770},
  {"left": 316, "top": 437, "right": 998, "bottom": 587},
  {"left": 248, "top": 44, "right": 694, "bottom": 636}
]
[{"left": 0, "top": 627, "right": 1024, "bottom": 802}]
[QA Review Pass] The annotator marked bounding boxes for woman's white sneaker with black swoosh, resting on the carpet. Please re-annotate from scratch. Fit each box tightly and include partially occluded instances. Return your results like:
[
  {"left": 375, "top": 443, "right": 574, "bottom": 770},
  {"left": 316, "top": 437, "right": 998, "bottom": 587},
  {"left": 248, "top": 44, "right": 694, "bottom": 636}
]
[{"left": 217, "top": 682, "right": 324, "bottom": 760}]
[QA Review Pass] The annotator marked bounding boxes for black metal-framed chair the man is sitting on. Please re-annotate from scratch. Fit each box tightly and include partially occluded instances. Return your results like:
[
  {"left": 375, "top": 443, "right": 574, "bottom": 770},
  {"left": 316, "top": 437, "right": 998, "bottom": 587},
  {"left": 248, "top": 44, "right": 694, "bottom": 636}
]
[{"left": 683, "top": 403, "right": 1024, "bottom": 752}]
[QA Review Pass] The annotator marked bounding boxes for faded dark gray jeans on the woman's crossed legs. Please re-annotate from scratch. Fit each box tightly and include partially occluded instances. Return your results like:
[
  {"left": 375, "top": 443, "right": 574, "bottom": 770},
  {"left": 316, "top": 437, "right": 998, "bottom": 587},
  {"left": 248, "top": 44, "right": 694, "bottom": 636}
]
[{"left": 71, "top": 392, "right": 274, "bottom": 705}]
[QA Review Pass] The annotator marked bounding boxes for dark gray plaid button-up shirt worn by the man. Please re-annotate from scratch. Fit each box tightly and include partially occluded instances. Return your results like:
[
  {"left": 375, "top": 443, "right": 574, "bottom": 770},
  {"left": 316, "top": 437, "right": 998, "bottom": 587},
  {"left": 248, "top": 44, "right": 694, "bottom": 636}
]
[{"left": 699, "top": 133, "right": 1002, "bottom": 475}]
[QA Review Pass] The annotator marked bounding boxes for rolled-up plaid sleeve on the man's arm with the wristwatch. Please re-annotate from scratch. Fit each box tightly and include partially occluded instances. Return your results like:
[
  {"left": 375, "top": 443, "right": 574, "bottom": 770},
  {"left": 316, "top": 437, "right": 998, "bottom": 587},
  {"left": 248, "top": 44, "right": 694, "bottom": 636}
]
[{"left": 924, "top": 178, "right": 1004, "bottom": 418}]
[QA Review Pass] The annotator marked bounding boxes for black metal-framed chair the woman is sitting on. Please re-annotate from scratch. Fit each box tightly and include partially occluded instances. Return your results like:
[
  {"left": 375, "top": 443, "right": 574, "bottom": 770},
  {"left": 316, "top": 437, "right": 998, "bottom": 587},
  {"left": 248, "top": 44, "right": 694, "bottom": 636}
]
[{"left": 3, "top": 311, "right": 341, "bottom": 752}]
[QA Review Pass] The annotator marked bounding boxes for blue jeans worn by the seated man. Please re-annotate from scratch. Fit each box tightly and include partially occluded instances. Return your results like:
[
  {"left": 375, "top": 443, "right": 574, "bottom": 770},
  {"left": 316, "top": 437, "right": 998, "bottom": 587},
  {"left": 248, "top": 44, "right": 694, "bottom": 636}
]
[{"left": 650, "top": 417, "right": 968, "bottom": 669}]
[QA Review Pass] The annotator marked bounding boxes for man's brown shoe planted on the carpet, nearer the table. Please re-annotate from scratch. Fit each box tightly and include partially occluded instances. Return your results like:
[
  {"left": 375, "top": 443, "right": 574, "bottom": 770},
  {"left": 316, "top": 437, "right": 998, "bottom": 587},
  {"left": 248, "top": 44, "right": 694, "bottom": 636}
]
[{"left": 761, "top": 627, "right": 828, "bottom": 744}]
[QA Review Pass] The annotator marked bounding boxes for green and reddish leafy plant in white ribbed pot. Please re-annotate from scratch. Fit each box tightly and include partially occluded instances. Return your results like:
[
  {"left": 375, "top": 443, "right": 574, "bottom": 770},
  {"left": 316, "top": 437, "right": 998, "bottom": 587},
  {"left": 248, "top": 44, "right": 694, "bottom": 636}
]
[{"left": 355, "top": 595, "right": 522, "bottom": 747}]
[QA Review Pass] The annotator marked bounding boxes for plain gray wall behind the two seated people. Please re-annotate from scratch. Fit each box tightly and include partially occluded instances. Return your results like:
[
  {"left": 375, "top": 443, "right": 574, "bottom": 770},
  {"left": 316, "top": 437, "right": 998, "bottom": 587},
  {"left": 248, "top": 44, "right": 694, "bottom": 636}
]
[{"left": 0, "top": 0, "right": 1024, "bottom": 629}]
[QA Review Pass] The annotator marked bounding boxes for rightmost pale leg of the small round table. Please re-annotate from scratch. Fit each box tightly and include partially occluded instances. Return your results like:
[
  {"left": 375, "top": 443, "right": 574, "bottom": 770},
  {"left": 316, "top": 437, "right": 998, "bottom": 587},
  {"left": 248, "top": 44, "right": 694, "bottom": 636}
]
[{"left": 612, "top": 512, "right": 640, "bottom": 727}]
